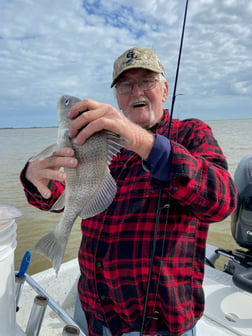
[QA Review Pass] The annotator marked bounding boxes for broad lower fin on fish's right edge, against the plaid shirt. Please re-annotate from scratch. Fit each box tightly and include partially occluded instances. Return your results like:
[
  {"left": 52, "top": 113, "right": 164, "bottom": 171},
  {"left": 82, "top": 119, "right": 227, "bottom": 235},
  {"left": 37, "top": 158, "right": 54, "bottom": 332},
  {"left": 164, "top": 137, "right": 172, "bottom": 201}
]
[{"left": 79, "top": 171, "right": 117, "bottom": 219}]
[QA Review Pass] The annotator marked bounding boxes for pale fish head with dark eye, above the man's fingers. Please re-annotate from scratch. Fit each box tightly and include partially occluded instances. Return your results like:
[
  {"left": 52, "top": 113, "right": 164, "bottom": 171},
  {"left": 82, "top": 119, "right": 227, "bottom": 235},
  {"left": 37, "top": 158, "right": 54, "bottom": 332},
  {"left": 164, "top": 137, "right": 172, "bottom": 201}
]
[{"left": 57, "top": 95, "right": 81, "bottom": 128}]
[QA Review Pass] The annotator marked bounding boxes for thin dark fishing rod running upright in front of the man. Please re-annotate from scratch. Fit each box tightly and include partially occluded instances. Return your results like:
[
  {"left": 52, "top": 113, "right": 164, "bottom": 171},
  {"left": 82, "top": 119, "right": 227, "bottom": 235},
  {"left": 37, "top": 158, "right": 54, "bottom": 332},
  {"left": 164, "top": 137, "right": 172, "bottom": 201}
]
[{"left": 140, "top": 0, "right": 189, "bottom": 336}]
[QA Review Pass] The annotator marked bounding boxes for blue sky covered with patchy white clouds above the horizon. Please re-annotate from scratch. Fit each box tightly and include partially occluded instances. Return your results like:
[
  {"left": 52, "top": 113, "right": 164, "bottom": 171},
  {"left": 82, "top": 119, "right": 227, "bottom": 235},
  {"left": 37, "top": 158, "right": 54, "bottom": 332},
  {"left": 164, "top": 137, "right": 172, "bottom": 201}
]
[{"left": 0, "top": 0, "right": 252, "bottom": 127}]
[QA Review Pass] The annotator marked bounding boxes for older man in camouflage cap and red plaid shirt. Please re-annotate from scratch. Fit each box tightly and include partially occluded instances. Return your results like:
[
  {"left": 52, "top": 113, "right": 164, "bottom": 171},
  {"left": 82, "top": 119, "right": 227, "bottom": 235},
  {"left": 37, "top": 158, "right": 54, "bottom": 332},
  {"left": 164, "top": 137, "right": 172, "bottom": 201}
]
[{"left": 21, "top": 48, "right": 236, "bottom": 336}]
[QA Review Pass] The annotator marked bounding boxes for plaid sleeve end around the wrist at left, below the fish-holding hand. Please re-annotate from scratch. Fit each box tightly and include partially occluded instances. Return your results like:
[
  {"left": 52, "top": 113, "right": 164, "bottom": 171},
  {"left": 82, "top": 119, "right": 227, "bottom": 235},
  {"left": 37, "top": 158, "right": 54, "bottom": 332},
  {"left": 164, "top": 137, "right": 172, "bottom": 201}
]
[{"left": 20, "top": 162, "right": 65, "bottom": 212}]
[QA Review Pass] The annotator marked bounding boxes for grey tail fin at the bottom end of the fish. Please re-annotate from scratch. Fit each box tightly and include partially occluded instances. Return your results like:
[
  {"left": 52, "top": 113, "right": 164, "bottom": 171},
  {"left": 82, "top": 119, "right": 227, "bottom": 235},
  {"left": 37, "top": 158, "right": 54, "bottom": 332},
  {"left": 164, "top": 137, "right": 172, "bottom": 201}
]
[{"left": 34, "top": 231, "right": 67, "bottom": 274}]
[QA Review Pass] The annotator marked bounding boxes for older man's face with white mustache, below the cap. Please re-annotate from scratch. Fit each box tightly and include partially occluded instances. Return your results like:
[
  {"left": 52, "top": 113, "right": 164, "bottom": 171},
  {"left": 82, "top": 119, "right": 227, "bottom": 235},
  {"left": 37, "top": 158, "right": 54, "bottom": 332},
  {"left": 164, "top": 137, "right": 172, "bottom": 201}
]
[{"left": 116, "top": 68, "right": 168, "bottom": 128}]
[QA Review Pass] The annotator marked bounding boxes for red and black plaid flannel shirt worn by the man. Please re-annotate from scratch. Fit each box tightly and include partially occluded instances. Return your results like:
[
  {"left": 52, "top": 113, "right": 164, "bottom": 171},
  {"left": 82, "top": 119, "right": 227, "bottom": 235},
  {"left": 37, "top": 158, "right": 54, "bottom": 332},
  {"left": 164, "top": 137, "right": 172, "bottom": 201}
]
[{"left": 20, "top": 113, "right": 236, "bottom": 336}]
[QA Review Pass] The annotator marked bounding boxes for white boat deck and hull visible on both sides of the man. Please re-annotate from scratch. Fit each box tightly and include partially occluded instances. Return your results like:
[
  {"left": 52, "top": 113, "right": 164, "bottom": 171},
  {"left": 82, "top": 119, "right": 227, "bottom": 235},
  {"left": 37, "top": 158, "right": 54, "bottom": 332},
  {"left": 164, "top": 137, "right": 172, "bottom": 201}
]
[{"left": 17, "top": 248, "right": 252, "bottom": 336}]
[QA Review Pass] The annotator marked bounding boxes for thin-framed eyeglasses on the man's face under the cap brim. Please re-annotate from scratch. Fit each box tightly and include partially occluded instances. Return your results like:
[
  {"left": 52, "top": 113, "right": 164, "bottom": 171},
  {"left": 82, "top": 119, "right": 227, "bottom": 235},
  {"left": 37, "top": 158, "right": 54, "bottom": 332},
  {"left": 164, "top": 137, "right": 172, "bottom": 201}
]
[{"left": 115, "top": 77, "right": 159, "bottom": 94}]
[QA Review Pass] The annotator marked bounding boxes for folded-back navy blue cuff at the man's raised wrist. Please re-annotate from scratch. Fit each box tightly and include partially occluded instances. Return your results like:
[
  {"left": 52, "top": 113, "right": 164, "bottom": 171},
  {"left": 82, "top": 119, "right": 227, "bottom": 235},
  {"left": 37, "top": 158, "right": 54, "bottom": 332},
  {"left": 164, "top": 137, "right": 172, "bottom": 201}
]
[{"left": 142, "top": 134, "right": 171, "bottom": 183}]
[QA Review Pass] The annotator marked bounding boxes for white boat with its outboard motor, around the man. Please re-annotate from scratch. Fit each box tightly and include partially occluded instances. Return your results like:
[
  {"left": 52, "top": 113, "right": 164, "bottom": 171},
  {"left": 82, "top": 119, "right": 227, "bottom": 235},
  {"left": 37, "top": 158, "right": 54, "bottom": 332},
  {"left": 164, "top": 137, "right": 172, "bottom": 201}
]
[{"left": 13, "top": 156, "right": 252, "bottom": 336}]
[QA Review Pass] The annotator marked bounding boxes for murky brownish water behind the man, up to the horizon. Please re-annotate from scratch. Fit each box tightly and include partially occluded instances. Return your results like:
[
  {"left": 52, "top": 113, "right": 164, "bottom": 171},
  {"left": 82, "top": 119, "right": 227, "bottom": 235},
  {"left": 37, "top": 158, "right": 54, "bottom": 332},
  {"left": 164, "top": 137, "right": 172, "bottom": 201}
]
[{"left": 0, "top": 119, "right": 252, "bottom": 274}]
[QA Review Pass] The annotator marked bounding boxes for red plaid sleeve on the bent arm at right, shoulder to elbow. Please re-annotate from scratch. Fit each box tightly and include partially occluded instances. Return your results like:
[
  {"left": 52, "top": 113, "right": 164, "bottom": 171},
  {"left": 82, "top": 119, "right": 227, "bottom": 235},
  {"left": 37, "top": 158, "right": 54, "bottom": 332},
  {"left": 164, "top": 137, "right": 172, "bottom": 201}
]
[{"left": 167, "top": 119, "right": 237, "bottom": 223}]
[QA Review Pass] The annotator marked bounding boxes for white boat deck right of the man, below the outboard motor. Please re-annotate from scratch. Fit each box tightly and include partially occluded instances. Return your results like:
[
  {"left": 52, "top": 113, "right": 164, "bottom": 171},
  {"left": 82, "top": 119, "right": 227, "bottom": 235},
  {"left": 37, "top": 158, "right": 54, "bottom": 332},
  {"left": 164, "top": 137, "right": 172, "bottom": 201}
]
[{"left": 198, "top": 266, "right": 252, "bottom": 336}]
